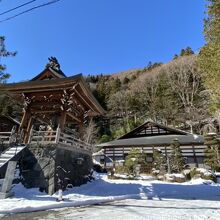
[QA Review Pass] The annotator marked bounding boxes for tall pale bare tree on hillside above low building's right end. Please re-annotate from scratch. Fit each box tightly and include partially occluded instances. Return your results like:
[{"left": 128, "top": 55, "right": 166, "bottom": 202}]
[{"left": 166, "top": 56, "right": 207, "bottom": 132}]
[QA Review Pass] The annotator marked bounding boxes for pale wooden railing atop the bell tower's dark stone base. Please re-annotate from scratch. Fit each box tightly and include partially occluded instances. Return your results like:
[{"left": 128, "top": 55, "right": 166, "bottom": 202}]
[{"left": 28, "top": 128, "right": 92, "bottom": 151}]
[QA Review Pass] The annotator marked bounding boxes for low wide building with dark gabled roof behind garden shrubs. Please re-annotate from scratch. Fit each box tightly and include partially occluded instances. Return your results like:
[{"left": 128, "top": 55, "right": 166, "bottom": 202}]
[{"left": 95, "top": 121, "right": 206, "bottom": 167}]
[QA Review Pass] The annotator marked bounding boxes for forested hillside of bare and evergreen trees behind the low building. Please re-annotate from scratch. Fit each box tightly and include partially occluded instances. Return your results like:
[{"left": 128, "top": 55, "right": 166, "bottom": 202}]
[{"left": 86, "top": 47, "right": 218, "bottom": 142}]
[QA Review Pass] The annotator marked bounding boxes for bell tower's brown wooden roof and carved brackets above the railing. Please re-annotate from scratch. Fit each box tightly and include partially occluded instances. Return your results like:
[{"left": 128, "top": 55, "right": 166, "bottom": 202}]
[{"left": 0, "top": 57, "right": 104, "bottom": 143}]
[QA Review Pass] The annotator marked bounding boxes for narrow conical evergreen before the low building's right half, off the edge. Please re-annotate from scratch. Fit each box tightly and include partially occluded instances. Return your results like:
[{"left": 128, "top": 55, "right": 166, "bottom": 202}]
[{"left": 169, "top": 139, "right": 185, "bottom": 172}]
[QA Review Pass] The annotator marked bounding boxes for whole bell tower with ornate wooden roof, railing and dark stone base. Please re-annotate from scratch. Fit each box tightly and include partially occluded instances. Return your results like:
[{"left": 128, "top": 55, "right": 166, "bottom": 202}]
[{"left": 0, "top": 57, "right": 104, "bottom": 194}]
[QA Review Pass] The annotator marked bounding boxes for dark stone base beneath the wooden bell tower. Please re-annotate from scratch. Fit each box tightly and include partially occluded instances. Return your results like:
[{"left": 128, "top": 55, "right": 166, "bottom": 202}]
[{"left": 20, "top": 145, "right": 92, "bottom": 194}]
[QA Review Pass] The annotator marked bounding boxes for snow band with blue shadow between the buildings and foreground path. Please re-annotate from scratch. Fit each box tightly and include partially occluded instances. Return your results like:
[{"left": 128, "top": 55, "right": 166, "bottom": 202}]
[{"left": 0, "top": 175, "right": 220, "bottom": 218}]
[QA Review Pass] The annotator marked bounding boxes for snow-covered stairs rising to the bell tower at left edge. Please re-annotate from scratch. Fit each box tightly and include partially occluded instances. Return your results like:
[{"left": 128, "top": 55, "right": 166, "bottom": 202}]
[{"left": 0, "top": 145, "right": 26, "bottom": 169}]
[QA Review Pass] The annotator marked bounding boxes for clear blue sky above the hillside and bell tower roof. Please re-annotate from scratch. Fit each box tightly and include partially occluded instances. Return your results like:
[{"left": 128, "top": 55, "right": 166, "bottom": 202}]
[{"left": 0, "top": 0, "right": 206, "bottom": 81}]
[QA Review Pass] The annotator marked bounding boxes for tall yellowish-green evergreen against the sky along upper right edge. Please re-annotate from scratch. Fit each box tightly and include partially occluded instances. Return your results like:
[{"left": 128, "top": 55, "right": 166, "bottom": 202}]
[{"left": 198, "top": 0, "right": 220, "bottom": 109}]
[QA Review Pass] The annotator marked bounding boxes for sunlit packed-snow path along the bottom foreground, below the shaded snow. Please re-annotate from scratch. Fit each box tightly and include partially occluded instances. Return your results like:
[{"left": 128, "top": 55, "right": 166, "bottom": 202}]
[{"left": 2, "top": 199, "right": 220, "bottom": 220}]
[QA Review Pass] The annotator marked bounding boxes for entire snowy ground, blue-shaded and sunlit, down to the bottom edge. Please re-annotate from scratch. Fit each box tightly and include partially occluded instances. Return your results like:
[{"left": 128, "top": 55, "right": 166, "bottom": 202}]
[{"left": 0, "top": 176, "right": 220, "bottom": 220}]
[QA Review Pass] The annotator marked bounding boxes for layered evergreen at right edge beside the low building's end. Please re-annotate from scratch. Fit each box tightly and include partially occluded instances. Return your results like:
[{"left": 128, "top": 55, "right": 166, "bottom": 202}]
[{"left": 204, "top": 134, "right": 220, "bottom": 171}]
